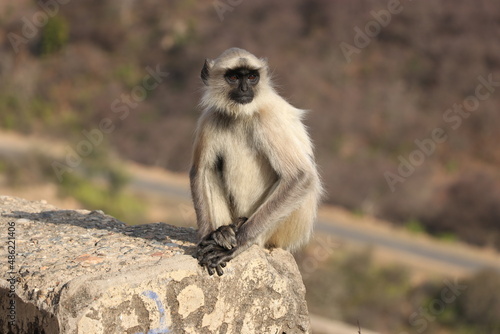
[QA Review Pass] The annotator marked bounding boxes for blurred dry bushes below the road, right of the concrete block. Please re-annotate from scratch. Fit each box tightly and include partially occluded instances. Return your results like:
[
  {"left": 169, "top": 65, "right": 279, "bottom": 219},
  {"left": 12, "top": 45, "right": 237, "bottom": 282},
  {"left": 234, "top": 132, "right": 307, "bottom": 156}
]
[{"left": 298, "top": 250, "right": 500, "bottom": 334}]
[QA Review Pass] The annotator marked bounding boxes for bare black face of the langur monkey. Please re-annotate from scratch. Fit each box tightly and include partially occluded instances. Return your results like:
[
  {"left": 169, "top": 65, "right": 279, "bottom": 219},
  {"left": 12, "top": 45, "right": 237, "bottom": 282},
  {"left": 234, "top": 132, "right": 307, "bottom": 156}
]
[{"left": 224, "top": 67, "right": 260, "bottom": 104}]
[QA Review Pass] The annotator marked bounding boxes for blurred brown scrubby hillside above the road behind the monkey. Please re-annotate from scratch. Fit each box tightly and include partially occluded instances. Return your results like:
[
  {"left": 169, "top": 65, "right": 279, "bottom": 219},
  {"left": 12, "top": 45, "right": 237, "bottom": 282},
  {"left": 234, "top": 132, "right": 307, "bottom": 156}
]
[{"left": 0, "top": 0, "right": 500, "bottom": 247}]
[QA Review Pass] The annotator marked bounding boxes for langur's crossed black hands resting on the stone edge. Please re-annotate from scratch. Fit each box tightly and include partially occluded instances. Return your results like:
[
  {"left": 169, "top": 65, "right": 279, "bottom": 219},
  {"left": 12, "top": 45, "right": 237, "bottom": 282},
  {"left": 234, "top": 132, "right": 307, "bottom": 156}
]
[{"left": 196, "top": 217, "right": 248, "bottom": 276}]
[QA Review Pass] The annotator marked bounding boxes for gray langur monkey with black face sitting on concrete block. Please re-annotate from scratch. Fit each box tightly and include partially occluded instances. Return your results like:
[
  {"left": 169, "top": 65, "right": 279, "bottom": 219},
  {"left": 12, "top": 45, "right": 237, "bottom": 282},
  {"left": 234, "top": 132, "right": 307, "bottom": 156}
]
[{"left": 190, "top": 48, "right": 322, "bottom": 275}]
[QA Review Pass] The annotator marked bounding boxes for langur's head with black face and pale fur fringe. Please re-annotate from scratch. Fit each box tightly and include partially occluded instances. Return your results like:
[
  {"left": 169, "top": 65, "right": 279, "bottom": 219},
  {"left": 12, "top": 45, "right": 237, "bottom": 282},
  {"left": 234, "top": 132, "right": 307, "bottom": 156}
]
[{"left": 201, "top": 48, "right": 271, "bottom": 116}]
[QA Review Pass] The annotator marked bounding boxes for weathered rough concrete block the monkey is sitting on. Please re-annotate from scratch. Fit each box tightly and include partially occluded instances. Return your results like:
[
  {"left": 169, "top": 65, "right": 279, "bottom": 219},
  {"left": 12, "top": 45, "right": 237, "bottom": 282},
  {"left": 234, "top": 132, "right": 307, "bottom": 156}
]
[{"left": 0, "top": 196, "right": 309, "bottom": 334}]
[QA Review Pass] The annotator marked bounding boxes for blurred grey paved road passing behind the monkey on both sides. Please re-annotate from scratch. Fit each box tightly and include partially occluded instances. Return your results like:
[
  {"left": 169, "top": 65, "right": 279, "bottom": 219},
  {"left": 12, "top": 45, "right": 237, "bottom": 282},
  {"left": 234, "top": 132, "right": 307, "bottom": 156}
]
[{"left": 131, "top": 177, "right": 500, "bottom": 273}]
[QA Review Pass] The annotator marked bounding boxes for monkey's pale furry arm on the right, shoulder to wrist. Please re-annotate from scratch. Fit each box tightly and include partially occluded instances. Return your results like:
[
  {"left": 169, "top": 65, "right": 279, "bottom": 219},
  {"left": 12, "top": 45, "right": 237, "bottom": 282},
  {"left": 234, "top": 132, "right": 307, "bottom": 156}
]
[{"left": 237, "top": 108, "right": 320, "bottom": 246}]
